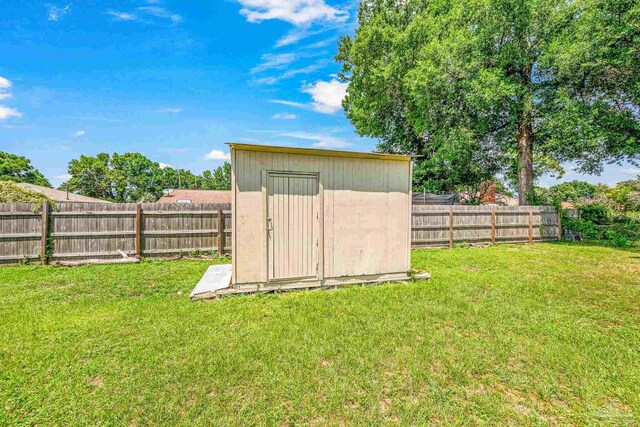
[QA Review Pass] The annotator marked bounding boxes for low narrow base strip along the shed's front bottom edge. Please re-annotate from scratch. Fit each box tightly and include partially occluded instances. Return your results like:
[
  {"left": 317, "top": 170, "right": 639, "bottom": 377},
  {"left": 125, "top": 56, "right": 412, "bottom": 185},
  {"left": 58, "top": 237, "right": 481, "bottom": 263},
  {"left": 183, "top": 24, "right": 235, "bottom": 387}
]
[{"left": 191, "top": 272, "right": 431, "bottom": 301}]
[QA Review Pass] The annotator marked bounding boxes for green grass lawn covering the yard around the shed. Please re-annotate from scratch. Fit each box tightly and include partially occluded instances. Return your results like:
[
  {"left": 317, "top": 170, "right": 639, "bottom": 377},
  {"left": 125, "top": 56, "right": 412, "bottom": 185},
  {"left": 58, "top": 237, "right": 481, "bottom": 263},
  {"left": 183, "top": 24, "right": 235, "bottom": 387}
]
[{"left": 0, "top": 244, "right": 640, "bottom": 425}]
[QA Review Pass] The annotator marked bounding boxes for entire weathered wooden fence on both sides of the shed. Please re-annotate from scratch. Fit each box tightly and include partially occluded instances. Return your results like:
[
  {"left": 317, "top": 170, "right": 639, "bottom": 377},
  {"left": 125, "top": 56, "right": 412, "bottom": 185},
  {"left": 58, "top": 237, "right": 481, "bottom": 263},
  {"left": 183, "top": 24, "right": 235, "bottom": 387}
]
[{"left": 0, "top": 202, "right": 561, "bottom": 264}]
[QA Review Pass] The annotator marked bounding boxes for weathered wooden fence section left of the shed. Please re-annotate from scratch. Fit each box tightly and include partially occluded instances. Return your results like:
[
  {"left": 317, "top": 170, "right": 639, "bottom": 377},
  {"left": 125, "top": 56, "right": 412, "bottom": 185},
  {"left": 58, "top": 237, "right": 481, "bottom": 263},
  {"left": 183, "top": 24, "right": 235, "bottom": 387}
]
[{"left": 0, "top": 202, "right": 231, "bottom": 264}]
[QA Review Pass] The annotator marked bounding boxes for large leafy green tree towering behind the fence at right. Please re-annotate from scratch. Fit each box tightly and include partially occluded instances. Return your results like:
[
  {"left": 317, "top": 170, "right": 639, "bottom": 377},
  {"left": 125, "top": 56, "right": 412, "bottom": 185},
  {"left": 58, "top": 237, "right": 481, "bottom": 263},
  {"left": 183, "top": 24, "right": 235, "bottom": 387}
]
[{"left": 337, "top": 0, "right": 640, "bottom": 204}]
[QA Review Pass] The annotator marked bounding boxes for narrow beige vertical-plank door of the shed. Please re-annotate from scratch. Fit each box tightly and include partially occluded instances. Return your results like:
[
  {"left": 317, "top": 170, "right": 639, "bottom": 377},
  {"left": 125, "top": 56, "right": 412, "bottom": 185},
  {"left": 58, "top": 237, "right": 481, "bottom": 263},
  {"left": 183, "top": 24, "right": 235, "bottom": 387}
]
[{"left": 267, "top": 173, "right": 320, "bottom": 281}]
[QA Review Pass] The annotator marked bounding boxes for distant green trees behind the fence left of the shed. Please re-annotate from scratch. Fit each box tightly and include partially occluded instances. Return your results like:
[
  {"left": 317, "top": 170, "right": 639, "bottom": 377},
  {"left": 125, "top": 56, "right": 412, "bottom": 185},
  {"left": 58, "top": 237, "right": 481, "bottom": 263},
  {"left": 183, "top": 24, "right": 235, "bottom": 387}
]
[{"left": 0, "top": 151, "right": 231, "bottom": 203}]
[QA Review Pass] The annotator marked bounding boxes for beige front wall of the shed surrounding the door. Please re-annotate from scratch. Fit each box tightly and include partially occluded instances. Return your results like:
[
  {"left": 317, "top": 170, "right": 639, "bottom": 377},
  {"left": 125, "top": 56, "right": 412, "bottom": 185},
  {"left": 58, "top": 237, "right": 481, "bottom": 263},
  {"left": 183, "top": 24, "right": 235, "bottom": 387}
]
[{"left": 232, "top": 149, "right": 411, "bottom": 284}]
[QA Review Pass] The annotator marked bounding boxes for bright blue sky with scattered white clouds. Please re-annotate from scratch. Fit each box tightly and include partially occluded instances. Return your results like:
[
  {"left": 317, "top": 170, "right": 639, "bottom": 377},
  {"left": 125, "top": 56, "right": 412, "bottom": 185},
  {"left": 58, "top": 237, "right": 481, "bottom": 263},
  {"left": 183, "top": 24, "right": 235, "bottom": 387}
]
[{"left": 0, "top": 0, "right": 640, "bottom": 185}]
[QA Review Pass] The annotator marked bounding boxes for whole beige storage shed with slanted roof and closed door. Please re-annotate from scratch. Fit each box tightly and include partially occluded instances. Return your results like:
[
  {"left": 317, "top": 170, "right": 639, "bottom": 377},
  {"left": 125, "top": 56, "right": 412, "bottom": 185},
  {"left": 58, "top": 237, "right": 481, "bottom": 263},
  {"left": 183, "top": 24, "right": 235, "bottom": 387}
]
[{"left": 229, "top": 143, "right": 412, "bottom": 291}]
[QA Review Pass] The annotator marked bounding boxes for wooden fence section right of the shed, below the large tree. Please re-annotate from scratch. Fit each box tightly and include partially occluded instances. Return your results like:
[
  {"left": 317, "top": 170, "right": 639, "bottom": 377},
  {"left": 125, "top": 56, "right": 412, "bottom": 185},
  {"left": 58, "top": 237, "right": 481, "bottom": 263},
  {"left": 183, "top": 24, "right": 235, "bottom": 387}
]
[{"left": 411, "top": 205, "right": 561, "bottom": 248}]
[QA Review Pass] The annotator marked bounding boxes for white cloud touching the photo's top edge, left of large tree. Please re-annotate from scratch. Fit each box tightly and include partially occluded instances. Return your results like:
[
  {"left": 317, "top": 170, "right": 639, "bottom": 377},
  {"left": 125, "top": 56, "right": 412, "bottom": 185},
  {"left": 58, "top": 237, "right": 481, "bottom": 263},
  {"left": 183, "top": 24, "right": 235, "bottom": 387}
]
[{"left": 237, "top": 0, "right": 349, "bottom": 26}]
